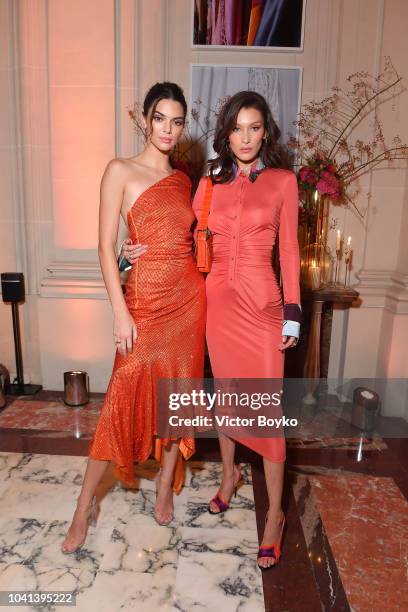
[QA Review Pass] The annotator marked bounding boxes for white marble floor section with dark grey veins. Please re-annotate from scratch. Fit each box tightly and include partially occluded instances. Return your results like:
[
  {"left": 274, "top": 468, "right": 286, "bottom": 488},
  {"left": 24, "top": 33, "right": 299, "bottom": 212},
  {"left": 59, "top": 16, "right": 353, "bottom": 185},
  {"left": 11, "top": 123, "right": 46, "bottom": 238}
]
[{"left": 0, "top": 453, "right": 264, "bottom": 612}]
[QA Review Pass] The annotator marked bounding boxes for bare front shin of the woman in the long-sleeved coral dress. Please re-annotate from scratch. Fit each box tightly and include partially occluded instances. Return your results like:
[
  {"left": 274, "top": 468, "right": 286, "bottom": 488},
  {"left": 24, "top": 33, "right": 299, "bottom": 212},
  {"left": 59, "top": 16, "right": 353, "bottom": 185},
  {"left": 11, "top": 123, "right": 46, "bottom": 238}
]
[{"left": 258, "top": 457, "right": 285, "bottom": 567}]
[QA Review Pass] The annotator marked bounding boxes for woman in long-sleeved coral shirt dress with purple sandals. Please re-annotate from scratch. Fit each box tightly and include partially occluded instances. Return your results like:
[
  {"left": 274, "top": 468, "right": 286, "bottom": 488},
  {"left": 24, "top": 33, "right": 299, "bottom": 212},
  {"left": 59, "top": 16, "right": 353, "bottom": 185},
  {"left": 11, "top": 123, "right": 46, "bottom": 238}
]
[{"left": 193, "top": 91, "right": 301, "bottom": 569}]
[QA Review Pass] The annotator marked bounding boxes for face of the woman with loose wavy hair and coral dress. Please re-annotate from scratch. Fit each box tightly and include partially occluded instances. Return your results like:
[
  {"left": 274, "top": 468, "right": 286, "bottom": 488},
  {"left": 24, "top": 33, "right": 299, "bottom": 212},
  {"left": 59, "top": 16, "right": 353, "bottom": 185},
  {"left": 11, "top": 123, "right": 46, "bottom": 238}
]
[{"left": 229, "top": 108, "right": 266, "bottom": 164}]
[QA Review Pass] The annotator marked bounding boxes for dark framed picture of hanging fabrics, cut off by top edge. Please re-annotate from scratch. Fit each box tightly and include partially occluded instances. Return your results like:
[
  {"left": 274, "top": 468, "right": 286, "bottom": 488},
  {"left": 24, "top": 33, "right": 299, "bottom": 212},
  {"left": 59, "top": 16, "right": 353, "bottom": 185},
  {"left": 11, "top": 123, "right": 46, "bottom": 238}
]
[{"left": 192, "top": 0, "right": 306, "bottom": 51}]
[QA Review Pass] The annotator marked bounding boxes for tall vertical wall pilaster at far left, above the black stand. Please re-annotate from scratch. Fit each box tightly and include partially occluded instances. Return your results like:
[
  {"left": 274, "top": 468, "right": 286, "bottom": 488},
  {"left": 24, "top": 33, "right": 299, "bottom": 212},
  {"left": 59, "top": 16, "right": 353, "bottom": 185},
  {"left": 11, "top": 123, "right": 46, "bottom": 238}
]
[{"left": 10, "top": 0, "right": 54, "bottom": 295}]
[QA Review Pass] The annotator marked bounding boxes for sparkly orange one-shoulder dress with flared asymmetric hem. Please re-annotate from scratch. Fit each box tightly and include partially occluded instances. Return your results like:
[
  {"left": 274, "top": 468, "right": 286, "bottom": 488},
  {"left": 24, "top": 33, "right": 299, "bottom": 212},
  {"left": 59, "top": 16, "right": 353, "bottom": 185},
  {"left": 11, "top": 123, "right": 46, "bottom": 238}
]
[{"left": 89, "top": 170, "right": 205, "bottom": 493}]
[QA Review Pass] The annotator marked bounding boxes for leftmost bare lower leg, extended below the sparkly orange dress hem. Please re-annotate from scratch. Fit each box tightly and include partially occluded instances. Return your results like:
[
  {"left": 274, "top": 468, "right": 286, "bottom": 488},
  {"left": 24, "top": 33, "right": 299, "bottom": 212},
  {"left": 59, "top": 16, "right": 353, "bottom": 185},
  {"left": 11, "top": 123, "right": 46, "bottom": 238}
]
[{"left": 62, "top": 459, "right": 110, "bottom": 552}]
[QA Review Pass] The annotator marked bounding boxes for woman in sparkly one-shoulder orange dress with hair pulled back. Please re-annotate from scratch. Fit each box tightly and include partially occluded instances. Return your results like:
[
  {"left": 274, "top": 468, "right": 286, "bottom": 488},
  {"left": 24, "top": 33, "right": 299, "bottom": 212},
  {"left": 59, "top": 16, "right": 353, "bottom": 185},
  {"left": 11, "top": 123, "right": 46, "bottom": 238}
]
[{"left": 62, "top": 83, "right": 205, "bottom": 553}]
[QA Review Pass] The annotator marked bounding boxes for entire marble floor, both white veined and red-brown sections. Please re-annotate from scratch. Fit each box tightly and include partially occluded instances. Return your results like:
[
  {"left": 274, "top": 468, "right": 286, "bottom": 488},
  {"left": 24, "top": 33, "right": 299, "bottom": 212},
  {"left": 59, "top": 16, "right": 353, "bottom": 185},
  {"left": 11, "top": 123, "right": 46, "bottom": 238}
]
[{"left": 0, "top": 392, "right": 408, "bottom": 612}]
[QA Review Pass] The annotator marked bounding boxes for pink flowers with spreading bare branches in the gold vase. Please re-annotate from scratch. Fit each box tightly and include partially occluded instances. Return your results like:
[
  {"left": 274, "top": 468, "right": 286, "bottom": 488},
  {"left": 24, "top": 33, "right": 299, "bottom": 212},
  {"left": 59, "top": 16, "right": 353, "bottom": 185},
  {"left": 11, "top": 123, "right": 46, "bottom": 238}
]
[{"left": 288, "top": 57, "right": 408, "bottom": 217}]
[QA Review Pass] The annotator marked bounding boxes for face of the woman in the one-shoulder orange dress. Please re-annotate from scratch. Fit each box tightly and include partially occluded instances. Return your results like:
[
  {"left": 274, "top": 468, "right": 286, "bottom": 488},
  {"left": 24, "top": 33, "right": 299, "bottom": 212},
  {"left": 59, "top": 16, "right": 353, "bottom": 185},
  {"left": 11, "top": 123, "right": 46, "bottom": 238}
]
[{"left": 143, "top": 99, "right": 185, "bottom": 153}]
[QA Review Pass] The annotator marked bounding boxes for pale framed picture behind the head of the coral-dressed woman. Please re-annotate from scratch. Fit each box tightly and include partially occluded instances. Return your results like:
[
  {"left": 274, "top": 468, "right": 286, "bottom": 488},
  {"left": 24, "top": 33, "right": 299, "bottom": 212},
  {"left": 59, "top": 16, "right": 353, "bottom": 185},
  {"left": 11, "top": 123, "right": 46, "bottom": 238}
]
[{"left": 189, "top": 64, "right": 303, "bottom": 159}]
